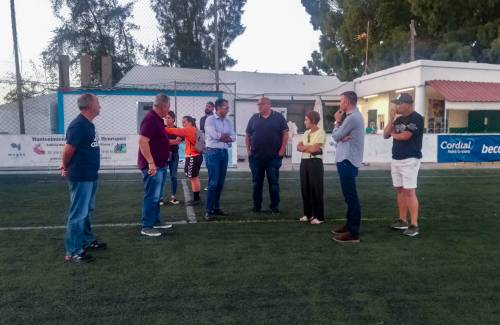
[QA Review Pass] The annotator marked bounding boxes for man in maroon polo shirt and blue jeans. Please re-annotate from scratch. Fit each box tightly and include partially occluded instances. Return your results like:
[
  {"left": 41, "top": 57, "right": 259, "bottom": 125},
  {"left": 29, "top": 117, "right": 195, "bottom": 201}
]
[{"left": 137, "top": 93, "right": 172, "bottom": 237}]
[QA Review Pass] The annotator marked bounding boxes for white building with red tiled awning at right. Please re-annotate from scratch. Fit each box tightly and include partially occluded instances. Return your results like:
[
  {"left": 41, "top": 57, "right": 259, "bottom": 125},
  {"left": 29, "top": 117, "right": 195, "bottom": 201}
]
[{"left": 353, "top": 60, "right": 500, "bottom": 133}]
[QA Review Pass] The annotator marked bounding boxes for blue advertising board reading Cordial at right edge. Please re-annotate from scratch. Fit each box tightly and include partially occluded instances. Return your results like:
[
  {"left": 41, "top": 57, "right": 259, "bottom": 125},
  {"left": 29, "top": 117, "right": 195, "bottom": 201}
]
[{"left": 437, "top": 134, "right": 500, "bottom": 163}]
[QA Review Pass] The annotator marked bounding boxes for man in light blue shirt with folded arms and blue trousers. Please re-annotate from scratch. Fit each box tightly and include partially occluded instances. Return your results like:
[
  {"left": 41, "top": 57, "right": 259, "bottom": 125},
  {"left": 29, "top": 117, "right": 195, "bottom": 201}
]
[{"left": 205, "top": 98, "right": 236, "bottom": 221}]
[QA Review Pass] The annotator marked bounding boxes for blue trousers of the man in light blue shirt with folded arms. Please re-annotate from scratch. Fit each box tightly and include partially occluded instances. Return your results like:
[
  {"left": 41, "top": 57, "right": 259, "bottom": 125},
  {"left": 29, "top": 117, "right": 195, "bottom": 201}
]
[{"left": 205, "top": 148, "right": 228, "bottom": 213}]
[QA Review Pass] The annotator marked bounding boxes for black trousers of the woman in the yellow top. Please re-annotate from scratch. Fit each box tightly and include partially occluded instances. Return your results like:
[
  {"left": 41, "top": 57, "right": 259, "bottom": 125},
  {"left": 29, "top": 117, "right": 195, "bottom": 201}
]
[{"left": 300, "top": 158, "right": 325, "bottom": 220}]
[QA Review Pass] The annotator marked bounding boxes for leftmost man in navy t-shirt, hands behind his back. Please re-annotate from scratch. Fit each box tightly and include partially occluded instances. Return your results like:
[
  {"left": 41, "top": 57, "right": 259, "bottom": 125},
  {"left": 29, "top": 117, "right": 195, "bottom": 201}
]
[{"left": 60, "top": 94, "right": 106, "bottom": 263}]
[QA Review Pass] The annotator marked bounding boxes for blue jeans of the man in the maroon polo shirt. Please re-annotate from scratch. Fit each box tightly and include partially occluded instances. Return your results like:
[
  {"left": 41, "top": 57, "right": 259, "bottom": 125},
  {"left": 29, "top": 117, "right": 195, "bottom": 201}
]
[{"left": 141, "top": 167, "right": 166, "bottom": 228}]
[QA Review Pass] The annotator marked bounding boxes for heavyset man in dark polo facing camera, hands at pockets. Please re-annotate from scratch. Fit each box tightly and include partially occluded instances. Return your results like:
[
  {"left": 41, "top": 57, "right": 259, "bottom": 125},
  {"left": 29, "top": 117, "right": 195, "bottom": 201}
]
[{"left": 245, "top": 97, "right": 288, "bottom": 213}]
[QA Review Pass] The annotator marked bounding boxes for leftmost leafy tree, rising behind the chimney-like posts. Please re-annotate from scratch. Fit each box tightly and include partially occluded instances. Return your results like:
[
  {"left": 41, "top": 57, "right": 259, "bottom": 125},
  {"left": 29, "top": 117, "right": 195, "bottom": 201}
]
[{"left": 42, "top": 0, "right": 142, "bottom": 84}]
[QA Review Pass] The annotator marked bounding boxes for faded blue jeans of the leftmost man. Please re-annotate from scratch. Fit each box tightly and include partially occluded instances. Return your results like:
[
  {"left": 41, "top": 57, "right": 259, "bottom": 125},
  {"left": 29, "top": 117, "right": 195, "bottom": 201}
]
[{"left": 65, "top": 181, "right": 98, "bottom": 256}]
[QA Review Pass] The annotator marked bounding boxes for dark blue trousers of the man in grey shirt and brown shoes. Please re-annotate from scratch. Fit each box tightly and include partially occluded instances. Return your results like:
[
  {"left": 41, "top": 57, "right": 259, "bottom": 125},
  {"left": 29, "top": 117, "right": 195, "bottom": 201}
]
[{"left": 337, "top": 159, "right": 361, "bottom": 237}]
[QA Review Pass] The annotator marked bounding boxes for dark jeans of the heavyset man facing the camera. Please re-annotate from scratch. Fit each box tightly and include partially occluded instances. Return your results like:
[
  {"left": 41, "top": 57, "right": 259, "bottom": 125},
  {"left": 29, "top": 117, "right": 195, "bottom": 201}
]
[{"left": 249, "top": 156, "right": 282, "bottom": 209}]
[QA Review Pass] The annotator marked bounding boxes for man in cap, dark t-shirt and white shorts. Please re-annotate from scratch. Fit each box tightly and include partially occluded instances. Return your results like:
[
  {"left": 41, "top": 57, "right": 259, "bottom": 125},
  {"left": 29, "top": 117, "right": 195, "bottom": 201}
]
[{"left": 384, "top": 93, "right": 424, "bottom": 237}]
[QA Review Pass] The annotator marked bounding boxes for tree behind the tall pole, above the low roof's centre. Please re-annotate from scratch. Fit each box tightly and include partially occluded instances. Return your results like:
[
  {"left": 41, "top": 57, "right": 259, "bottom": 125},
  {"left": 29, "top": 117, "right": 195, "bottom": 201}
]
[{"left": 146, "top": 0, "right": 246, "bottom": 69}]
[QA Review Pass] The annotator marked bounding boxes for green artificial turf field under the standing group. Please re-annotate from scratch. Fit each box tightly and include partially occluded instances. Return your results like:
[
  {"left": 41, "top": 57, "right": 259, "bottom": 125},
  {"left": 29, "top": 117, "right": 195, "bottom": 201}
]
[{"left": 0, "top": 170, "right": 500, "bottom": 324}]
